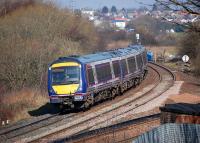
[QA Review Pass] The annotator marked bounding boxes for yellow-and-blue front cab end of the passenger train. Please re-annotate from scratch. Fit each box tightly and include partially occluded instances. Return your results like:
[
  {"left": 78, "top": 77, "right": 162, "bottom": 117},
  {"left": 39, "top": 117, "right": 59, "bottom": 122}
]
[{"left": 48, "top": 61, "right": 86, "bottom": 108}]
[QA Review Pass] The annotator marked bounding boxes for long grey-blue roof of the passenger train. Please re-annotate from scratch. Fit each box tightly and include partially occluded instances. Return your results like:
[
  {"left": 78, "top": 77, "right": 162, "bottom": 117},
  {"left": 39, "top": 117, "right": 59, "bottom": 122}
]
[{"left": 52, "top": 45, "right": 145, "bottom": 64}]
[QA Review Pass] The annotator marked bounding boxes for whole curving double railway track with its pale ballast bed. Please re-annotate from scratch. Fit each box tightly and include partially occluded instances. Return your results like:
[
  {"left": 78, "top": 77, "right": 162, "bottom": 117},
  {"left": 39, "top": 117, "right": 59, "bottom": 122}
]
[{"left": 0, "top": 63, "right": 175, "bottom": 142}]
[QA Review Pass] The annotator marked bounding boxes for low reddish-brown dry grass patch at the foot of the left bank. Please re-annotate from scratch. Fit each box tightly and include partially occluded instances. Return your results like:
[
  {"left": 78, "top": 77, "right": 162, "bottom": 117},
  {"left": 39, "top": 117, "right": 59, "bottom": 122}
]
[{"left": 0, "top": 89, "right": 48, "bottom": 122}]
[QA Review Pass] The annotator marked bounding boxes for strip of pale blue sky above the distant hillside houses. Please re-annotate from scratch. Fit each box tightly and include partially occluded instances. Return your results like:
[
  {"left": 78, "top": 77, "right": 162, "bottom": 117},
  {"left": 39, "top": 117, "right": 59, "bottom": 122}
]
[{"left": 55, "top": 0, "right": 155, "bottom": 9}]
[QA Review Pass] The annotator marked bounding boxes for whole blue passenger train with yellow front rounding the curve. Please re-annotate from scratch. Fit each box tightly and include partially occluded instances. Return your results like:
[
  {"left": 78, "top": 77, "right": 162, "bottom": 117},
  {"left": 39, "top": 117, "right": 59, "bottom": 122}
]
[{"left": 48, "top": 45, "right": 147, "bottom": 109}]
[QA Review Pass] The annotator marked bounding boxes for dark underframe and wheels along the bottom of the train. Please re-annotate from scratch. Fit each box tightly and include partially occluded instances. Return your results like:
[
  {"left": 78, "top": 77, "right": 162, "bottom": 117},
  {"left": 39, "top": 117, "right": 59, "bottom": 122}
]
[{"left": 54, "top": 70, "right": 148, "bottom": 110}]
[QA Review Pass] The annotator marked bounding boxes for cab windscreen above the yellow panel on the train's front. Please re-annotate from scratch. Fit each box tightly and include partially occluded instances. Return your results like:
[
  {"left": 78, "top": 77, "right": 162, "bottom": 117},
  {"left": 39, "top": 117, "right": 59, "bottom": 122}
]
[{"left": 52, "top": 66, "right": 80, "bottom": 85}]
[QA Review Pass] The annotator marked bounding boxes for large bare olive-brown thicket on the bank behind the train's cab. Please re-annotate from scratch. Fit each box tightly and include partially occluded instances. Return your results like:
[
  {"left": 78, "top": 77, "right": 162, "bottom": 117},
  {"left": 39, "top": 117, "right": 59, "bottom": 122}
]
[{"left": 0, "top": 4, "right": 99, "bottom": 89}]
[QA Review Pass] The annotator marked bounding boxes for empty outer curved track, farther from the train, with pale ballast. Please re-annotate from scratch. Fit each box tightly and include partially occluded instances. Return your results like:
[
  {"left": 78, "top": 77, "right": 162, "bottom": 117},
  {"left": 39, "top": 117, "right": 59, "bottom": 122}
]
[{"left": 40, "top": 62, "right": 175, "bottom": 141}]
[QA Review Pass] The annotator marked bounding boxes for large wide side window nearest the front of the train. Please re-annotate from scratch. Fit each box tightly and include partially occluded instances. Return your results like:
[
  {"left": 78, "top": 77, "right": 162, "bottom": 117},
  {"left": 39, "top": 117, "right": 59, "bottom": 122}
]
[{"left": 95, "top": 63, "right": 112, "bottom": 83}]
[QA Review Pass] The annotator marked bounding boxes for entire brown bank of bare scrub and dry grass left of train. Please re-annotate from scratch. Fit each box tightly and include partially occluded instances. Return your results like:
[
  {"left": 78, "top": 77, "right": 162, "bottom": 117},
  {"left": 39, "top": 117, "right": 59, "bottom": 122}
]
[{"left": 0, "top": 0, "right": 102, "bottom": 121}]
